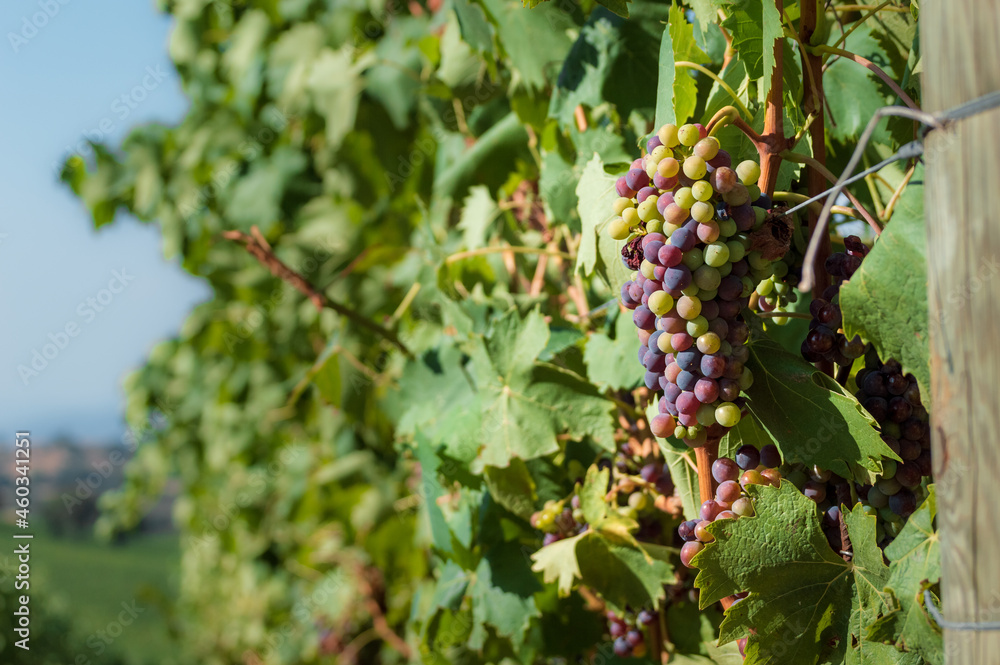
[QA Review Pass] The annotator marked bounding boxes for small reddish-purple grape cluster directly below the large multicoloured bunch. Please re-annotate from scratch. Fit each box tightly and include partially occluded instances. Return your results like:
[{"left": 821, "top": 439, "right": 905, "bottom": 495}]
[{"left": 677, "top": 444, "right": 781, "bottom": 568}]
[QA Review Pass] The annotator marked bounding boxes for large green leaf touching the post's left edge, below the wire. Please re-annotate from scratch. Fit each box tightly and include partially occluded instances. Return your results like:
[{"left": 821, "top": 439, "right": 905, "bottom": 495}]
[{"left": 840, "top": 166, "right": 931, "bottom": 408}]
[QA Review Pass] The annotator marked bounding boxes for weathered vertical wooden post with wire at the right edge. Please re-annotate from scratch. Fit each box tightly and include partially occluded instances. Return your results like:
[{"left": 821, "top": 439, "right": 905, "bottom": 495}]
[{"left": 920, "top": 0, "right": 1000, "bottom": 665}]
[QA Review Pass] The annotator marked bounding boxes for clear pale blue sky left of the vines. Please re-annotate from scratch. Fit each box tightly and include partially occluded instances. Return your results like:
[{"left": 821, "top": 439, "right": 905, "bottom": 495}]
[{"left": 0, "top": 0, "right": 210, "bottom": 442}]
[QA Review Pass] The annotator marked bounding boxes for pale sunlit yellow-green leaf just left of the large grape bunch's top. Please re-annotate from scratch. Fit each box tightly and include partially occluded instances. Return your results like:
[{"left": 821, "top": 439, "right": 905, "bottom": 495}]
[{"left": 576, "top": 153, "right": 631, "bottom": 292}]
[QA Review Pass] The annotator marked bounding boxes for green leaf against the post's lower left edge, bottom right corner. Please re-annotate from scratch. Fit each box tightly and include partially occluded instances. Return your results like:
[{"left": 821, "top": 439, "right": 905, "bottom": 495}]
[{"left": 868, "top": 485, "right": 944, "bottom": 664}]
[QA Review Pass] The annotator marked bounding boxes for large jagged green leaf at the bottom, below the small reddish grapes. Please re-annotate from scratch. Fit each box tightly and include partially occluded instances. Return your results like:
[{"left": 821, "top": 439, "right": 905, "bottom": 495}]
[{"left": 693, "top": 481, "right": 888, "bottom": 665}]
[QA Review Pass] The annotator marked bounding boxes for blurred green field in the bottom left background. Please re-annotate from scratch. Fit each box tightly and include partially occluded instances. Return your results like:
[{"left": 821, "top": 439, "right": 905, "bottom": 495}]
[{"left": 0, "top": 524, "right": 182, "bottom": 665}]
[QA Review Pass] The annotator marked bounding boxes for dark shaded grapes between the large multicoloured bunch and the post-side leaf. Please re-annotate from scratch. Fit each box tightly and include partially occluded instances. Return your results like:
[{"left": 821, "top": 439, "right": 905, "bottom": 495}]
[{"left": 801, "top": 236, "right": 868, "bottom": 365}]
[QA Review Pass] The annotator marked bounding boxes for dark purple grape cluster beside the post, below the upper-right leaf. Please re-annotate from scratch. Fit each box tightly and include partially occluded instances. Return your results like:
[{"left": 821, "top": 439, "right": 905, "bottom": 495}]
[{"left": 855, "top": 350, "right": 932, "bottom": 542}]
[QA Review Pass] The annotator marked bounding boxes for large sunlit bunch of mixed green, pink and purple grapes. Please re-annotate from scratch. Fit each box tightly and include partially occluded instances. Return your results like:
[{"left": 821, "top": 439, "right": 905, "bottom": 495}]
[{"left": 609, "top": 124, "right": 775, "bottom": 447}]
